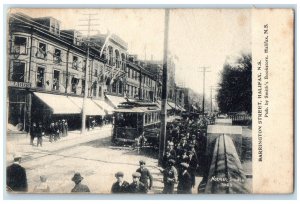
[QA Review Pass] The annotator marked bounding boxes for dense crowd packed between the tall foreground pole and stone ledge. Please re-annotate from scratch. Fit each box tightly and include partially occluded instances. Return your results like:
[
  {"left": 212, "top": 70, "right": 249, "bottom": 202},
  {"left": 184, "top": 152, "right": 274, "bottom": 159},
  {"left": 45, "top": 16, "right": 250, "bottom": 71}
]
[{"left": 162, "top": 117, "right": 213, "bottom": 194}]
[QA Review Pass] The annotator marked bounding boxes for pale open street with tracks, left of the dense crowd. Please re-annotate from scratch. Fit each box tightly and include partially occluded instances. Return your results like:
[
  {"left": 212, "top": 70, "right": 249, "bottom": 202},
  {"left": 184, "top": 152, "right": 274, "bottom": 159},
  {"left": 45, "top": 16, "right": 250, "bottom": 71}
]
[{"left": 7, "top": 126, "right": 201, "bottom": 194}]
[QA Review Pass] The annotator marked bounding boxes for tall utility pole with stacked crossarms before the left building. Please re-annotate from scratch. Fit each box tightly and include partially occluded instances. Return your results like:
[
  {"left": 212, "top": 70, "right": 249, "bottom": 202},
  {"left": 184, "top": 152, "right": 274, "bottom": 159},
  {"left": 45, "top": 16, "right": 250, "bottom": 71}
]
[{"left": 79, "top": 13, "right": 98, "bottom": 134}]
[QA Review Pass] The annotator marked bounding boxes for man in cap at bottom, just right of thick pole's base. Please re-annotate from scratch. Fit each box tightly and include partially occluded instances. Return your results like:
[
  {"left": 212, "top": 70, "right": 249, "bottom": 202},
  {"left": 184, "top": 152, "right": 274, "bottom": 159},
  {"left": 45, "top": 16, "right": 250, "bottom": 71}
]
[{"left": 161, "top": 159, "right": 177, "bottom": 194}]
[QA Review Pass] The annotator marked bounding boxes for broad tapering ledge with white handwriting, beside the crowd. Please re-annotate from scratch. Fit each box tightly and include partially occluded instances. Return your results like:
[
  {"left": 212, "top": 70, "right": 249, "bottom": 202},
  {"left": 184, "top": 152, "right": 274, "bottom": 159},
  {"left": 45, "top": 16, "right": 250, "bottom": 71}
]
[{"left": 198, "top": 135, "right": 249, "bottom": 194}]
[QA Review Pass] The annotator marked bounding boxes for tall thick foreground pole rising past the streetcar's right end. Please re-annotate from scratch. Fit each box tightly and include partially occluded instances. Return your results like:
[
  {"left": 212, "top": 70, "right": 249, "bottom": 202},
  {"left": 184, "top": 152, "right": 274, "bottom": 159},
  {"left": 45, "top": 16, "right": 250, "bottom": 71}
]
[{"left": 159, "top": 9, "right": 169, "bottom": 165}]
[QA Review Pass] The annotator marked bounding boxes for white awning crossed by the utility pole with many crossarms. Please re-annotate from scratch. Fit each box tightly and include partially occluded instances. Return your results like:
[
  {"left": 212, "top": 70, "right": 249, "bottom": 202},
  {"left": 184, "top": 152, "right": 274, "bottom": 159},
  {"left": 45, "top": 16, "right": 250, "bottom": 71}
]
[{"left": 69, "top": 97, "right": 106, "bottom": 116}]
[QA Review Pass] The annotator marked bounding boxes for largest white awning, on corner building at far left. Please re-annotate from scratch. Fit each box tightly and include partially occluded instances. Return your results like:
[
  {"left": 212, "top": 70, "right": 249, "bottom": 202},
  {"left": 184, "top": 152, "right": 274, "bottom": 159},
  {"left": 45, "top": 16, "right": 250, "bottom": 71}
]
[{"left": 34, "top": 92, "right": 81, "bottom": 114}]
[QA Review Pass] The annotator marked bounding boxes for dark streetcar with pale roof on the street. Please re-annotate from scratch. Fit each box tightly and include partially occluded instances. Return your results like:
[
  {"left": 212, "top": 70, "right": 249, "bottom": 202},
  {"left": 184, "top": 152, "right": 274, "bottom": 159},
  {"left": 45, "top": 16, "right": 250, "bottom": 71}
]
[{"left": 112, "top": 101, "right": 161, "bottom": 146}]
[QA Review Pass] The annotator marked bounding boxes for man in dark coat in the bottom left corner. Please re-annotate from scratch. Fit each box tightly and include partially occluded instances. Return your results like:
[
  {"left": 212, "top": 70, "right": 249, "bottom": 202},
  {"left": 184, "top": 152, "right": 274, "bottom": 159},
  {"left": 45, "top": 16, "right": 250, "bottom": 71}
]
[{"left": 6, "top": 155, "right": 28, "bottom": 192}]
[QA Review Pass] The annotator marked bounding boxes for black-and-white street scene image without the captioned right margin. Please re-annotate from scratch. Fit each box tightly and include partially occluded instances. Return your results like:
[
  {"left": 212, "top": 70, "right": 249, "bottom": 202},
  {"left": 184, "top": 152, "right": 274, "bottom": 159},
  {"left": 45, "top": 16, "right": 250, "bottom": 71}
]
[{"left": 5, "top": 7, "right": 292, "bottom": 196}]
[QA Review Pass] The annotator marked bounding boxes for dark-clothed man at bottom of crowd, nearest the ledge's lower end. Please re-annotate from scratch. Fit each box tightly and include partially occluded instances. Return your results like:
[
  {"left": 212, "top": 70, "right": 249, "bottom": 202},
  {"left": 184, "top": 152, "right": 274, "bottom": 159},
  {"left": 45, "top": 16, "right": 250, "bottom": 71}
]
[{"left": 177, "top": 163, "right": 192, "bottom": 194}]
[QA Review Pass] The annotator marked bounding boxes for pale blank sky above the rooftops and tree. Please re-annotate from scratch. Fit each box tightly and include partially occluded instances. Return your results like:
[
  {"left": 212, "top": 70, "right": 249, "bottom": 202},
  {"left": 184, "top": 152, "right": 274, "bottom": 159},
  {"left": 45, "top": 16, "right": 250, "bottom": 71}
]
[{"left": 11, "top": 8, "right": 251, "bottom": 95}]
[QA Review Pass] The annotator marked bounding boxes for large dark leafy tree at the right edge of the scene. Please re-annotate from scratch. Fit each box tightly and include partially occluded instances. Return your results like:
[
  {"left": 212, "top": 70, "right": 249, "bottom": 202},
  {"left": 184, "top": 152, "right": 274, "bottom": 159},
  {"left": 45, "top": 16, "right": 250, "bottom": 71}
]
[{"left": 217, "top": 54, "right": 252, "bottom": 113}]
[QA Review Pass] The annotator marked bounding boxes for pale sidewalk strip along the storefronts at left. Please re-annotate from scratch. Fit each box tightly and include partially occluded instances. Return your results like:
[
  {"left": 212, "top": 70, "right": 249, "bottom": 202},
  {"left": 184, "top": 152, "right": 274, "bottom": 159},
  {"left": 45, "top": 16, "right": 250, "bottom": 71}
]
[{"left": 6, "top": 125, "right": 112, "bottom": 163}]
